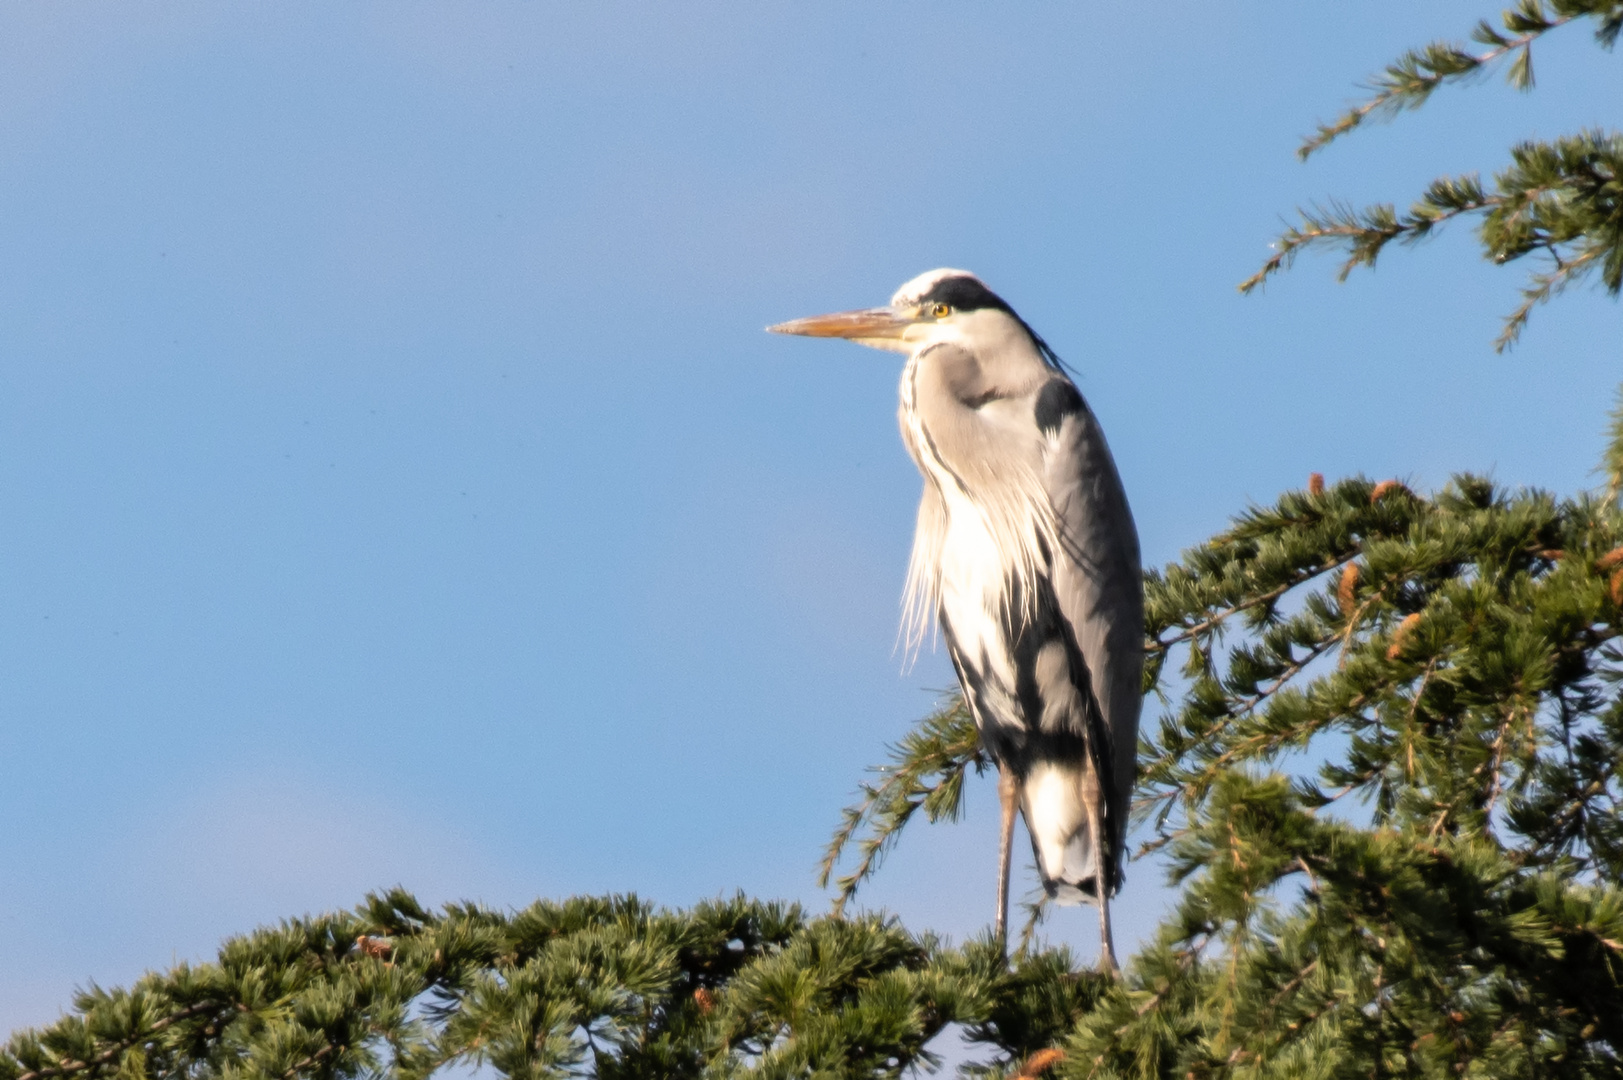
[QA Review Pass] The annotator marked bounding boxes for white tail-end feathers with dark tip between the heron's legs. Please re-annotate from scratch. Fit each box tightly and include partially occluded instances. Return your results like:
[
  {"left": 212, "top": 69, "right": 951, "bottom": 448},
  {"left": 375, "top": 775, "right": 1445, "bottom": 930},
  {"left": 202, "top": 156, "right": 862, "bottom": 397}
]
[{"left": 1021, "top": 762, "right": 1117, "bottom": 905}]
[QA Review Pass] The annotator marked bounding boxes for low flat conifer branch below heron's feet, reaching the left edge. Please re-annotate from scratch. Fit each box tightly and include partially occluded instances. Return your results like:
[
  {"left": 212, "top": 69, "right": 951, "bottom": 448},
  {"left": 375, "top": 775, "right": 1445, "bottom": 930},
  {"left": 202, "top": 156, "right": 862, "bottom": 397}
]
[{"left": 0, "top": 892, "right": 1104, "bottom": 1080}]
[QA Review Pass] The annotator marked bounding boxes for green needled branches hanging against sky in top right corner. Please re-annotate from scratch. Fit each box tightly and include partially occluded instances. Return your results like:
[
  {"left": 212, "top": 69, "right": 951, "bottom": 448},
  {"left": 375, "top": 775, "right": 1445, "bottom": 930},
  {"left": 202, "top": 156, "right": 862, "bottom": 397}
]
[{"left": 1240, "top": 0, "right": 1623, "bottom": 351}]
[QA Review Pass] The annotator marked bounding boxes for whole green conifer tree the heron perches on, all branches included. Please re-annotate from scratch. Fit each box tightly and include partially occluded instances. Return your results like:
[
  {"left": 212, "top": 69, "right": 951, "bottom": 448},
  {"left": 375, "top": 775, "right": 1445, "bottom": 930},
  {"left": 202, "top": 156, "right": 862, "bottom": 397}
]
[{"left": 12, "top": 0, "right": 1623, "bottom": 1080}]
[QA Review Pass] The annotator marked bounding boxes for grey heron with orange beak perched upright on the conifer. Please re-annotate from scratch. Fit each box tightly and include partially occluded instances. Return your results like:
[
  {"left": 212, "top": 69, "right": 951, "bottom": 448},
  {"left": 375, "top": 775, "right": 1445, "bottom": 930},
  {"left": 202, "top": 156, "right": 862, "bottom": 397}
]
[{"left": 769, "top": 270, "right": 1144, "bottom": 970}]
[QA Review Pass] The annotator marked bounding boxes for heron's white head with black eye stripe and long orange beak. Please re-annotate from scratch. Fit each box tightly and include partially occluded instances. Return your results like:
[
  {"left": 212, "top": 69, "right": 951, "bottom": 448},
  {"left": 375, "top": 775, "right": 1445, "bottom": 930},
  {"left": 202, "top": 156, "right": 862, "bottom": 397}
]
[{"left": 768, "top": 270, "right": 1035, "bottom": 352}]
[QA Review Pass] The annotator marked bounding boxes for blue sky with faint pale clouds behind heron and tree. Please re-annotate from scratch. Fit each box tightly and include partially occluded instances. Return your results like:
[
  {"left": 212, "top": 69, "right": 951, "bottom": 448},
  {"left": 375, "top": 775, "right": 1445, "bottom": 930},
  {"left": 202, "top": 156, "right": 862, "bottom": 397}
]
[{"left": 0, "top": 0, "right": 1623, "bottom": 1030}]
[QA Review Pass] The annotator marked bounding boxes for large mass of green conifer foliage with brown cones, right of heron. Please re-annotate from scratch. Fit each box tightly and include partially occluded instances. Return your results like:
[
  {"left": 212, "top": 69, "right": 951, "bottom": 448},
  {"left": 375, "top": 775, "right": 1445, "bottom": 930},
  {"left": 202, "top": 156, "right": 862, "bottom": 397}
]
[{"left": 824, "top": 412, "right": 1623, "bottom": 1077}]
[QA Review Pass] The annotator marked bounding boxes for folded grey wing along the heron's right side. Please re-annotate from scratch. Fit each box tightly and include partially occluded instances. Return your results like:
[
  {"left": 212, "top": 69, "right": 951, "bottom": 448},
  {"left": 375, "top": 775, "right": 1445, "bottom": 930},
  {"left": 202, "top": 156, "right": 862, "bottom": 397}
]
[{"left": 1035, "top": 377, "right": 1144, "bottom": 859}]
